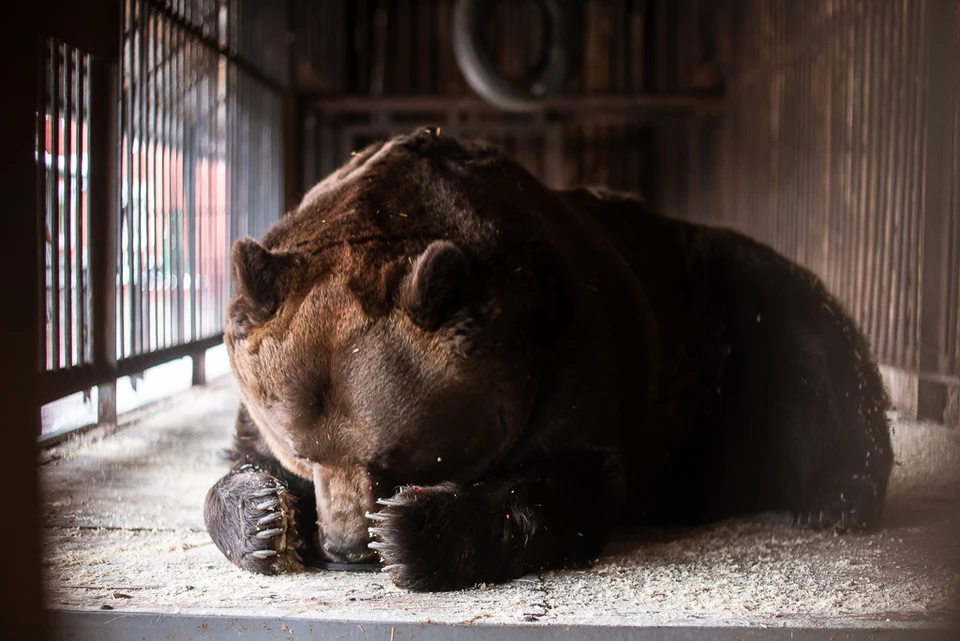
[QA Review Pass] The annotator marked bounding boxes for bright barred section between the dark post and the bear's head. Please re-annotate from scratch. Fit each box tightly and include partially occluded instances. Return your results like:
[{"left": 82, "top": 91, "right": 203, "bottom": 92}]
[{"left": 117, "top": 2, "right": 283, "bottom": 360}]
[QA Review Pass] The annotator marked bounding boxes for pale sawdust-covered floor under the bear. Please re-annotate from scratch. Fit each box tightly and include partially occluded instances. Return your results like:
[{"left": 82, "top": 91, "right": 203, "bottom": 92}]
[{"left": 40, "top": 381, "right": 960, "bottom": 641}]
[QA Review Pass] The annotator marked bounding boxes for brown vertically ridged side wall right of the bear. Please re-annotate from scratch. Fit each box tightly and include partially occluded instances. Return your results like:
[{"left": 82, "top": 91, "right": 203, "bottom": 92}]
[{"left": 711, "top": 0, "right": 960, "bottom": 418}]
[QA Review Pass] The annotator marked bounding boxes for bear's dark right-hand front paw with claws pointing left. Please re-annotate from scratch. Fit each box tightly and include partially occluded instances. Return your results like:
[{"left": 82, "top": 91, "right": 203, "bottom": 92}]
[{"left": 367, "top": 483, "right": 511, "bottom": 591}]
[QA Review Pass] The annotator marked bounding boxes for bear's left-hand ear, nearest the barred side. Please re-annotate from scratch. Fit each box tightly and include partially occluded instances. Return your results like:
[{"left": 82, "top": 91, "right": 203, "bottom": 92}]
[{"left": 231, "top": 238, "right": 296, "bottom": 325}]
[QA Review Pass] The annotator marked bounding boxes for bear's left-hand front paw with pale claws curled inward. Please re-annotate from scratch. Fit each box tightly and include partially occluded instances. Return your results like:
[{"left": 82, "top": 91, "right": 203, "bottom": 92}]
[{"left": 204, "top": 467, "right": 303, "bottom": 574}]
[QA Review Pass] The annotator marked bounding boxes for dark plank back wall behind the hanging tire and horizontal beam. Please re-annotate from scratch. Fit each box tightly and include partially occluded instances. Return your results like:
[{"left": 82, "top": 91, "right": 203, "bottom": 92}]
[{"left": 294, "top": 0, "right": 718, "bottom": 216}]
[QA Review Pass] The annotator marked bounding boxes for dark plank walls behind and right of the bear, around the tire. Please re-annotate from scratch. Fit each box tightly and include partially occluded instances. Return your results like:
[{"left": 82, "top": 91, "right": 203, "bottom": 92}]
[{"left": 293, "top": 0, "right": 960, "bottom": 422}]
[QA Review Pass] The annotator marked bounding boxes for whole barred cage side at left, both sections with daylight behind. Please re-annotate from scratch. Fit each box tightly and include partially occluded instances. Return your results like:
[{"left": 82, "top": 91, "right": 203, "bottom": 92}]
[{"left": 36, "top": 0, "right": 289, "bottom": 430}]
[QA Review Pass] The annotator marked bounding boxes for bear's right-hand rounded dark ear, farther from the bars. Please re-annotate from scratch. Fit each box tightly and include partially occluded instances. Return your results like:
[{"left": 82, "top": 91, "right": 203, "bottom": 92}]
[{"left": 399, "top": 240, "right": 473, "bottom": 331}]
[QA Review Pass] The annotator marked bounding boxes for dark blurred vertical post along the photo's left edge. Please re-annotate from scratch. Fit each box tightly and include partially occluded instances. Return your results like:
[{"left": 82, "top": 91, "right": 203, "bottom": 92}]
[{"left": 0, "top": 4, "right": 47, "bottom": 639}]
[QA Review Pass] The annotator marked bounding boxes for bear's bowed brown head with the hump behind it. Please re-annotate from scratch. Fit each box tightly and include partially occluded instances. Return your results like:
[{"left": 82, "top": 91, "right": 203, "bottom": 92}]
[{"left": 225, "top": 130, "right": 564, "bottom": 562}]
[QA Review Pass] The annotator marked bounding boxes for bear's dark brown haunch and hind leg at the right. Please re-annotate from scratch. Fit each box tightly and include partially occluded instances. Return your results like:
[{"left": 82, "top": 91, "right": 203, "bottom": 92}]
[{"left": 706, "top": 233, "right": 893, "bottom": 531}]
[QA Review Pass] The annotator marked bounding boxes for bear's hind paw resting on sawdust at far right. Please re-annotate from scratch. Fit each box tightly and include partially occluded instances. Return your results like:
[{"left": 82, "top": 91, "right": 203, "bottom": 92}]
[{"left": 794, "top": 474, "right": 882, "bottom": 533}]
